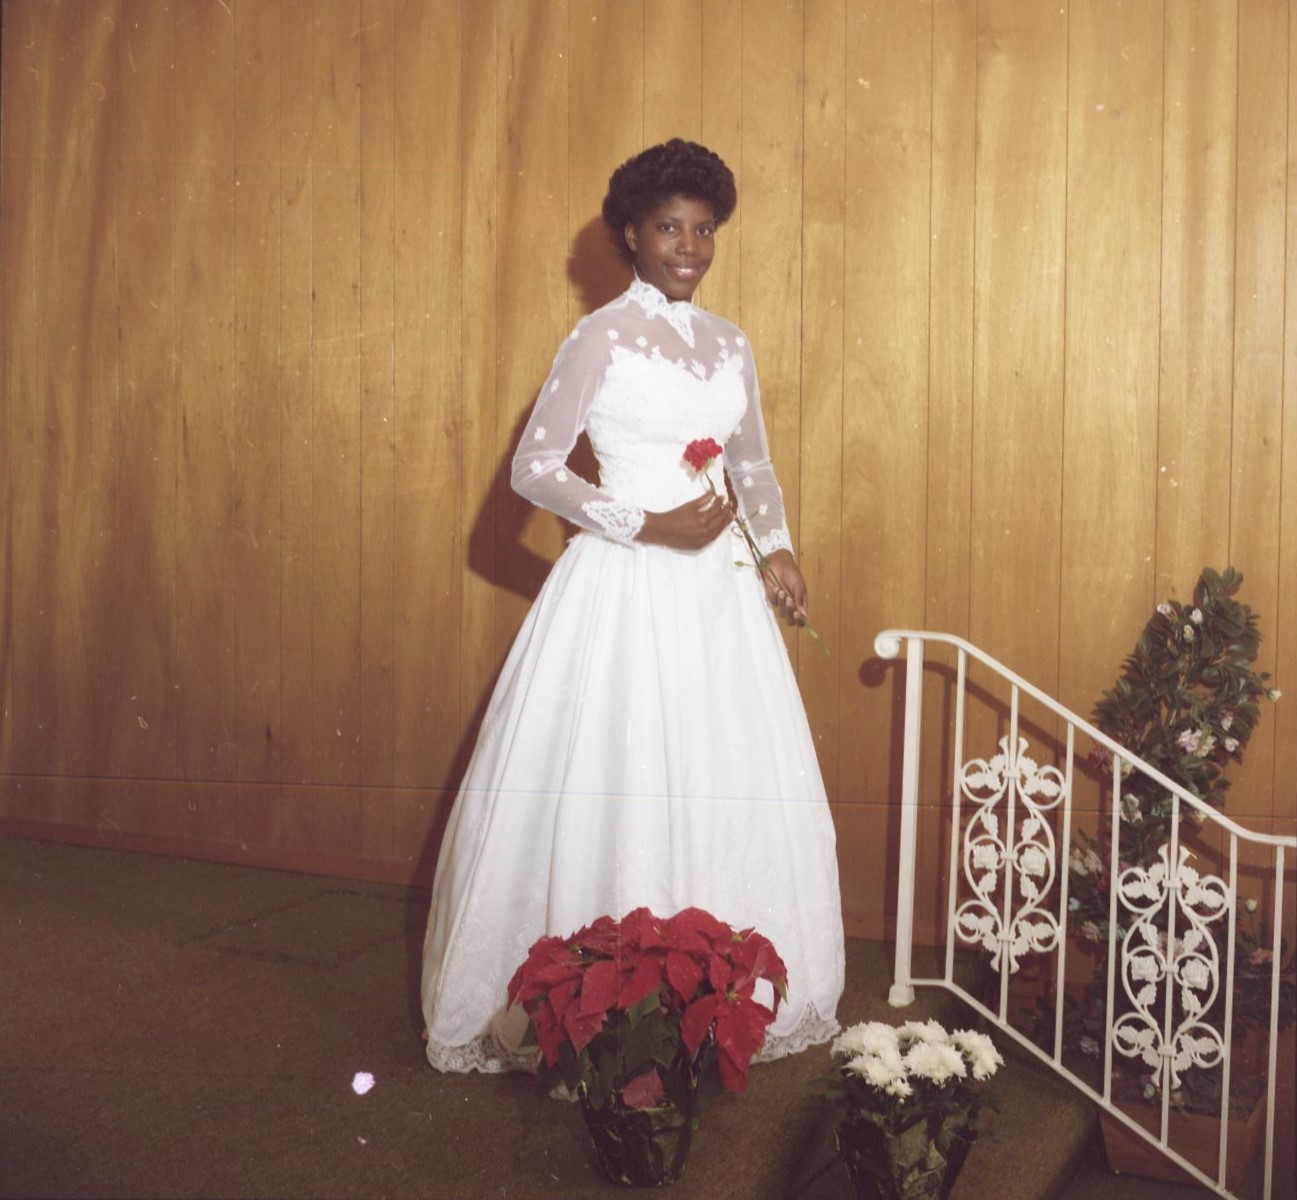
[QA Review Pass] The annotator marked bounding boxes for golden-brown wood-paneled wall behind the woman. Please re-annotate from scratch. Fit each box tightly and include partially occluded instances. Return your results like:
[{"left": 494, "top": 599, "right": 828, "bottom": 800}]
[{"left": 0, "top": 0, "right": 1297, "bottom": 933}]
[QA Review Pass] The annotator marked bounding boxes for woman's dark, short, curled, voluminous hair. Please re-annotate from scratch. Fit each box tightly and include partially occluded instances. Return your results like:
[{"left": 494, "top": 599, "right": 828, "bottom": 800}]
[{"left": 603, "top": 138, "right": 738, "bottom": 252}]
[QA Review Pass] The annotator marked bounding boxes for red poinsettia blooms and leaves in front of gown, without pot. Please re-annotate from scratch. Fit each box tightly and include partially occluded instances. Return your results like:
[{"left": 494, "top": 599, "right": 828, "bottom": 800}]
[{"left": 508, "top": 908, "right": 787, "bottom": 1123}]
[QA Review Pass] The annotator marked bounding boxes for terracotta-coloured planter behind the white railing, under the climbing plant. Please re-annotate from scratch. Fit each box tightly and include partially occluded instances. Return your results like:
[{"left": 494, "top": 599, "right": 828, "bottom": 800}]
[{"left": 1100, "top": 1098, "right": 1266, "bottom": 1191}]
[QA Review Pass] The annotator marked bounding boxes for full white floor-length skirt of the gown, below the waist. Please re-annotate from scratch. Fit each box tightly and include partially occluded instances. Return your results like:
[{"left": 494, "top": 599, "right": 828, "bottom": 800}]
[{"left": 423, "top": 531, "right": 843, "bottom": 1072}]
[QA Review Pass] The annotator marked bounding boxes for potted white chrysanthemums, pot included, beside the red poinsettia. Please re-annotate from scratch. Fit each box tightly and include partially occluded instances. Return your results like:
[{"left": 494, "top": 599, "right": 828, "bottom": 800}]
[{"left": 818, "top": 1021, "right": 1004, "bottom": 1200}]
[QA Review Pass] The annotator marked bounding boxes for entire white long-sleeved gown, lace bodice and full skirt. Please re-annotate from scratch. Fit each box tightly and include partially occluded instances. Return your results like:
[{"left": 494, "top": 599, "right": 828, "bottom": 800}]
[{"left": 423, "top": 279, "right": 843, "bottom": 1072}]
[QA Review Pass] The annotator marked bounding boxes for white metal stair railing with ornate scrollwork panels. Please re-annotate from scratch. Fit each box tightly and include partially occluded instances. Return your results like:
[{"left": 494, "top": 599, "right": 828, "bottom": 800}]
[{"left": 874, "top": 629, "right": 1297, "bottom": 1200}]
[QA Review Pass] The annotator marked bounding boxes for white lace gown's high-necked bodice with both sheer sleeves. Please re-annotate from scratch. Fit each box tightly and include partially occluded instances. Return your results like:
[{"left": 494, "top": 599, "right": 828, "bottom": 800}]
[{"left": 512, "top": 279, "right": 792, "bottom": 554}]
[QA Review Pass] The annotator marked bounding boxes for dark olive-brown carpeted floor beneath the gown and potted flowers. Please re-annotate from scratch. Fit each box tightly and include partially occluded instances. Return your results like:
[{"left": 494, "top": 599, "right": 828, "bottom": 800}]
[{"left": 0, "top": 839, "right": 1265, "bottom": 1200}]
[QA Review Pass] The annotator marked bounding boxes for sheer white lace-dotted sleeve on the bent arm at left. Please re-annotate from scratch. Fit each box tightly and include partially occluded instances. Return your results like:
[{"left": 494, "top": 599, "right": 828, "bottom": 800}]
[{"left": 511, "top": 320, "right": 645, "bottom": 545}]
